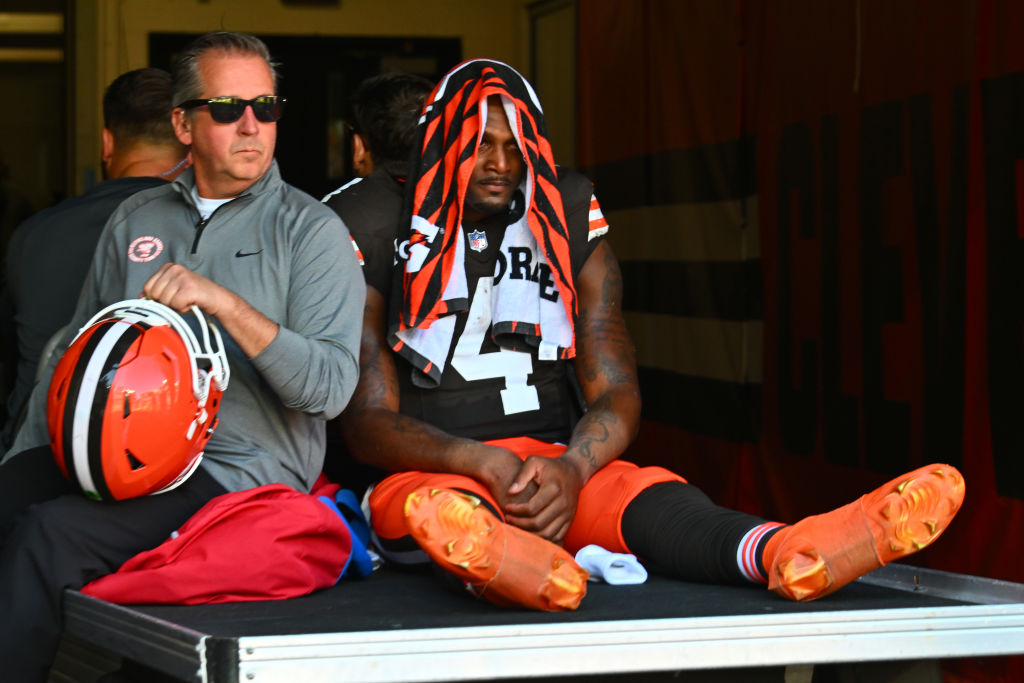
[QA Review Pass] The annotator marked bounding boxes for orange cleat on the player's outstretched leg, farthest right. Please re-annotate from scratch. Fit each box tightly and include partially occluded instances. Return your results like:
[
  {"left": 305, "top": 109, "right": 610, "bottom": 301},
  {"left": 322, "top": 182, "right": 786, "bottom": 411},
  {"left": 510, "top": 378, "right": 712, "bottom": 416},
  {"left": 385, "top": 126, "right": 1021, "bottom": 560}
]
[{"left": 764, "top": 465, "right": 965, "bottom": 600}]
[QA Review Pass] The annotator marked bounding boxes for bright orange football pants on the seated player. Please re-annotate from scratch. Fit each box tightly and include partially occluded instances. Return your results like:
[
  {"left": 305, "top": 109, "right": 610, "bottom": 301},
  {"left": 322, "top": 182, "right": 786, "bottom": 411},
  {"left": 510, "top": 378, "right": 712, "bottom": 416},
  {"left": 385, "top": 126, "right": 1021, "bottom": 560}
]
[{"left": 370, "top": 436, "right": 686, "bottom": 554}]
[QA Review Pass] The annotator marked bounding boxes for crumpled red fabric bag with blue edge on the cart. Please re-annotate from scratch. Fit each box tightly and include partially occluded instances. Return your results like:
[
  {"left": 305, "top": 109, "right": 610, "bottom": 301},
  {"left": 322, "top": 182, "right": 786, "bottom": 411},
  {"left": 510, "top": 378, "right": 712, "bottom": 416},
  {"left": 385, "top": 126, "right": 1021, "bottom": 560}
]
[{"left": 82, "top": 484, "right": 369, "bottom": 604}]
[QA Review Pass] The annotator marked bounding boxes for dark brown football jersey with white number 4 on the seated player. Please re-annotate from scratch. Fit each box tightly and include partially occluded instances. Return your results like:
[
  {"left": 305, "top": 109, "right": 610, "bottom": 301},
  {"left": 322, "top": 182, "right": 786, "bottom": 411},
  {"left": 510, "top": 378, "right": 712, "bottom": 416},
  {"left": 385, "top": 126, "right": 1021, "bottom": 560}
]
[{"left": 328, "top": 169, "right": 607, "bottom": 442}]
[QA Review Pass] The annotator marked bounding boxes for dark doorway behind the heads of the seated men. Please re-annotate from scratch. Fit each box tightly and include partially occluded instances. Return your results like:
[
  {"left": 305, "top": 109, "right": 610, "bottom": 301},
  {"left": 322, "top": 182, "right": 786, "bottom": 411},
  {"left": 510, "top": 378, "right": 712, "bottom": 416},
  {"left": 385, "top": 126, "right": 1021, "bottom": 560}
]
[{"left": 150, "top": 33, "right": 462, "bottom": 199}]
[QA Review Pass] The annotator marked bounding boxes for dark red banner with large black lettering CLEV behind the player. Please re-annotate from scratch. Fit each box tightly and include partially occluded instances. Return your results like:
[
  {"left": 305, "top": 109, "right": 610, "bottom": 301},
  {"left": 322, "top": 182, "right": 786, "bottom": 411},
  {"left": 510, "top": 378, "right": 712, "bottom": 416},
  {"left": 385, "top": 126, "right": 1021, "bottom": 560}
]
[{"left": 578, "top": 0, "right": 1024, "bottom": 671}]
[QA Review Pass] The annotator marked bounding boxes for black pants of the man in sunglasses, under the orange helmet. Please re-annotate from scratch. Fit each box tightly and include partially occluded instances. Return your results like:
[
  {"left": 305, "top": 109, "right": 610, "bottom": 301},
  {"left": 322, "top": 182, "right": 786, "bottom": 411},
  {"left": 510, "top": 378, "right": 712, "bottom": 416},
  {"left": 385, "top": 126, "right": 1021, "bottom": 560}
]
[{"left": 0, "top": 446, "right": 225, "bottom": 682}]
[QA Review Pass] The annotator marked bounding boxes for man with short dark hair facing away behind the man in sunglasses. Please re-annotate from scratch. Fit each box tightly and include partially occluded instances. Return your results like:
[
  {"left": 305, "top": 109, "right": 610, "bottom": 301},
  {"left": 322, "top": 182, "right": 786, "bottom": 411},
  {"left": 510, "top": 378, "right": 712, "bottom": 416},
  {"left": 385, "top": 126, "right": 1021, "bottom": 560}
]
[{"left": 0, "top": 69, "right": 188, "bottom": 447}]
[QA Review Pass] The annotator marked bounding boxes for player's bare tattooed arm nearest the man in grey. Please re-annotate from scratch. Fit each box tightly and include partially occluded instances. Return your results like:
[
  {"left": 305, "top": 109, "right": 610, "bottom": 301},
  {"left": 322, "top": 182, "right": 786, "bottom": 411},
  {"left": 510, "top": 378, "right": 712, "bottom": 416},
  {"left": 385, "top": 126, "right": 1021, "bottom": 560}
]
[{"left": 341, "top": 286, "right": 532, "bottom": 506}]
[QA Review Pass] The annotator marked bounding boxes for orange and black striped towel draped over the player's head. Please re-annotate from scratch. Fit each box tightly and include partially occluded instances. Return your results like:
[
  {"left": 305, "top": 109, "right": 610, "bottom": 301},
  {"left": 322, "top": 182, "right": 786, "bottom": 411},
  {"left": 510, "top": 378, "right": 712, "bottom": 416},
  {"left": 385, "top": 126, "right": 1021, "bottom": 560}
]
[{"left": 388, "top": 59, "right": 577, "bottom": 384}]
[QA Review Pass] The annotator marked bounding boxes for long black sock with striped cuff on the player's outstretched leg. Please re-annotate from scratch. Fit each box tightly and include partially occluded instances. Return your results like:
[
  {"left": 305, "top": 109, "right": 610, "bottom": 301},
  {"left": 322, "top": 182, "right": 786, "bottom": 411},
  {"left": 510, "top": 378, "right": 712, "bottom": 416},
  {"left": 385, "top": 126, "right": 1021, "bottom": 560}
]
[{"left": 623, "top": 481, "right": 771, "bottom": 584}]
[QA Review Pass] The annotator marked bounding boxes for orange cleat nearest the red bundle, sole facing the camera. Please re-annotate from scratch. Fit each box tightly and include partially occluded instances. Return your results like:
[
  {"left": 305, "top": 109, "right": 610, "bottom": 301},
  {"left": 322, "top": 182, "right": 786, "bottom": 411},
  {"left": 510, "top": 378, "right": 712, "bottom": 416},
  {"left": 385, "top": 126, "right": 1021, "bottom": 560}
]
[{"left": 404, "top": 488, "right": 590, "bottom": 611}]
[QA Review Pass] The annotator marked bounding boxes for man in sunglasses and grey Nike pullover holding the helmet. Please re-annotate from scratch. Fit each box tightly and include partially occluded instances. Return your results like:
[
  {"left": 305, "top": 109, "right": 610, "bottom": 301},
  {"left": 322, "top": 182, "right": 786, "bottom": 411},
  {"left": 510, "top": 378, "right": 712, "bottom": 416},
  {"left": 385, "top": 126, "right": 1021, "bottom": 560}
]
[{"left": 0, "top": 32, "right": 366, "bottom": 681}]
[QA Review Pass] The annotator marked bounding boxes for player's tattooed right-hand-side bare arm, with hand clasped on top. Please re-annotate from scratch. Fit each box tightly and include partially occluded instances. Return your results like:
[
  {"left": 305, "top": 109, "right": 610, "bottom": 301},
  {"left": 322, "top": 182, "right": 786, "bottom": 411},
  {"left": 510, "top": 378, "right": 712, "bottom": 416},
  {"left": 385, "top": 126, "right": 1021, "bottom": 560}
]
[{"left": 505, "top": 242, "right": 640, "bottom": 542}]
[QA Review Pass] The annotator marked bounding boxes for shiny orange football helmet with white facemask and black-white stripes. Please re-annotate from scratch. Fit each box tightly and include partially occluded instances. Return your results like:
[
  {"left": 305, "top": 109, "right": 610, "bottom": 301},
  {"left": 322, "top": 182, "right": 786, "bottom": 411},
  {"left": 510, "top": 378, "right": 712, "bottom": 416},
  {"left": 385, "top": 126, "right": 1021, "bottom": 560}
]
[{"left": 46, "top": 299, "right": 230, "bottom": 501}]
